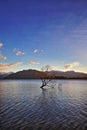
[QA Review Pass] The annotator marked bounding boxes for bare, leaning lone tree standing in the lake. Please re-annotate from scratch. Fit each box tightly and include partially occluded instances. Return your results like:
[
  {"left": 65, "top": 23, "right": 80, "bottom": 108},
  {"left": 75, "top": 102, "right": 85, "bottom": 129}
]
[{"left": 41, "top": 65, "right": 55, "bottom": 88}]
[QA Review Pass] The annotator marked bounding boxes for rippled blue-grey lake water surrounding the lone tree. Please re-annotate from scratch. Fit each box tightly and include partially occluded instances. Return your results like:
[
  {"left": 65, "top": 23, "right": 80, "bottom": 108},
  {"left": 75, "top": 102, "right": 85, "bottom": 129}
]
[{"left": 0, "top": 80, "right": 87, "bottom": 130}]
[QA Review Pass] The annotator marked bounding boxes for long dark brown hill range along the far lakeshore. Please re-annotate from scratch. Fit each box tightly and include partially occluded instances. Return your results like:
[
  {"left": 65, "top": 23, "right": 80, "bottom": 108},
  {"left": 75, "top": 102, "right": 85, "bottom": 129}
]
[{"left": 4, "top": 70, "right": 87, "bottom": 79}]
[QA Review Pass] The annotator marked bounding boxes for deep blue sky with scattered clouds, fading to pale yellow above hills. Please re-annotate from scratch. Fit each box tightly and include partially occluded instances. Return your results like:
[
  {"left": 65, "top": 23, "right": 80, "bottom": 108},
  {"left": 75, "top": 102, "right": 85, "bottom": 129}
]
[{"left": 0, "top": 0, "right": 87, "bottom": 73}]
